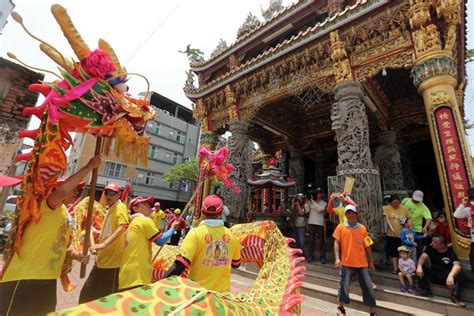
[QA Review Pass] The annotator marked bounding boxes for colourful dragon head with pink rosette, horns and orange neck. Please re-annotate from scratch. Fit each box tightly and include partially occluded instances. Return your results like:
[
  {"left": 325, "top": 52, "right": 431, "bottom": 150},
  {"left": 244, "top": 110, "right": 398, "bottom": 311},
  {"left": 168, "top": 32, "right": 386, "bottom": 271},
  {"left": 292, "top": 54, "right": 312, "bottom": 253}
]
[{"left": 2, "top": 4, "right": 156, "bottom": 264}]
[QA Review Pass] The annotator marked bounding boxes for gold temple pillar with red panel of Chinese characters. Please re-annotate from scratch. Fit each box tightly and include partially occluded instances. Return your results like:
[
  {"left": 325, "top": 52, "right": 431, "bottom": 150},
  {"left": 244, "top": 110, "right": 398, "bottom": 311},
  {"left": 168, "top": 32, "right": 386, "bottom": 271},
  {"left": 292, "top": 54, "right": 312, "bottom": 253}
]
[{"left": 409, "top": 1, "right": 472, "bottom": 259}]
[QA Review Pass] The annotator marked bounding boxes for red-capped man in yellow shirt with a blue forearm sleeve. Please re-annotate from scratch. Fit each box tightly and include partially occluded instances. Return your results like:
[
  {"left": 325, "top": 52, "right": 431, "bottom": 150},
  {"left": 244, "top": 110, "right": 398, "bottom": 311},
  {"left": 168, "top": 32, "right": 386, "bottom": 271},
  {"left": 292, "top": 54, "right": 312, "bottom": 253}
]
[{"left": 119, "top": 196, "right": 178, "bottom": 291}]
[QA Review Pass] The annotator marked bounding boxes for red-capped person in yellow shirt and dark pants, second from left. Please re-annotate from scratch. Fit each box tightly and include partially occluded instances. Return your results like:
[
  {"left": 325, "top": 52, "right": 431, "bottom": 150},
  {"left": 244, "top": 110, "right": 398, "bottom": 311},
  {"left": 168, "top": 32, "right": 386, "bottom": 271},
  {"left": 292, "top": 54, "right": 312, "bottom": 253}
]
[{"left": 79, "top": 183, "right": 129, "bottom": 304}]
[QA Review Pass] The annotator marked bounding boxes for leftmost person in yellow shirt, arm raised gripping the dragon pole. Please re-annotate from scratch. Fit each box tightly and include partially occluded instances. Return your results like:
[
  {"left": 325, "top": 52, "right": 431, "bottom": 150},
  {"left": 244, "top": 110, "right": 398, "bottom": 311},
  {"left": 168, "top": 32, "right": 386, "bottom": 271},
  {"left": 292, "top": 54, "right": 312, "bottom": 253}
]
[{"left": 0, "top": 156, "right": 100, "bottom": 316}]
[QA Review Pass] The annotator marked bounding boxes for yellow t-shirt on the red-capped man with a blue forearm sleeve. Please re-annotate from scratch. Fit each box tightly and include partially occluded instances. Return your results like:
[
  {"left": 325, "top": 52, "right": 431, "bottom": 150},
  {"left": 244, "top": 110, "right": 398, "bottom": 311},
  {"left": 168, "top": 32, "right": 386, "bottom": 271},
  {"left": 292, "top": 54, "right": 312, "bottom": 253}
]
[{"left": 119, "top": 215, "right": 161, "bottom": 289}]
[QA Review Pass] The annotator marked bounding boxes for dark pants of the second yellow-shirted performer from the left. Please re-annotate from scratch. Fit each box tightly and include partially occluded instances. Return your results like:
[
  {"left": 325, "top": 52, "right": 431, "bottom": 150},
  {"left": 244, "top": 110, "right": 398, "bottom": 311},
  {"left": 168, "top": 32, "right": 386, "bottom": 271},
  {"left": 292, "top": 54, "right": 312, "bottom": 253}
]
[{"left": 79, "top": 265, "right": 120, "bottom": 304}]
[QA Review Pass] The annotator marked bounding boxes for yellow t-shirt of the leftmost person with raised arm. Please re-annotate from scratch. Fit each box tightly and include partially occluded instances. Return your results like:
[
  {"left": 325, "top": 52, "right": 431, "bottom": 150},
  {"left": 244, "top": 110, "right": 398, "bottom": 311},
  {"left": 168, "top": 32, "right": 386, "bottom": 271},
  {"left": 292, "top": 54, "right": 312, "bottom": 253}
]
[{"left": 0, "top": 199, "right": 72, "bottom": 282}]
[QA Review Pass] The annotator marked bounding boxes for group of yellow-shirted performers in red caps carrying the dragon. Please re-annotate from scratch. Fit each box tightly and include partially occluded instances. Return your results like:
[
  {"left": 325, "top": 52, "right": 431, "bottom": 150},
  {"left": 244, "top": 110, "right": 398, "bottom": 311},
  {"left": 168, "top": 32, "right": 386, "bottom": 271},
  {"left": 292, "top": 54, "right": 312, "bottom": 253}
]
[{"left": 0, "top": 156, "right": 240, "bottom": 316}]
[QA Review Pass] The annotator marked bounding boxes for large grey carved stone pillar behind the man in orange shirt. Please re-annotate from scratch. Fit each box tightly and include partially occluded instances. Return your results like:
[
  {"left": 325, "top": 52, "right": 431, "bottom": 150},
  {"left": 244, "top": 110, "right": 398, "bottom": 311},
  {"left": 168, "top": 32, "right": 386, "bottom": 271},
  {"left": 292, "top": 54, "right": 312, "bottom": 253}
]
[{"left": 328, "top": 80, "right": 383, "bottom": 236}]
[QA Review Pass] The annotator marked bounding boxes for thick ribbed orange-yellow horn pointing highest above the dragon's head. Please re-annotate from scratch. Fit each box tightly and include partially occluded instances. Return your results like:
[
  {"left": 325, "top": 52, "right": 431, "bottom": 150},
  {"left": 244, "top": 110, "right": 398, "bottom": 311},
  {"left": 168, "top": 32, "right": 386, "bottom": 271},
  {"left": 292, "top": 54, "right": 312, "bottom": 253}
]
[{"left": 51, "top": 4, "right": 90, "bottom": 60}]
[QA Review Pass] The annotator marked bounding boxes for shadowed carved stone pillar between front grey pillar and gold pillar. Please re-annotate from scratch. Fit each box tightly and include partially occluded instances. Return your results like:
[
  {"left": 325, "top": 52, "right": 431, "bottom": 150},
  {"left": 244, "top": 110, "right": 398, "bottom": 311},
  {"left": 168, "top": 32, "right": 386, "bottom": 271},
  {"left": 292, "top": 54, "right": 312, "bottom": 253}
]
[{"left": 374, "top": 130, "right": 408, "bottom": 198}]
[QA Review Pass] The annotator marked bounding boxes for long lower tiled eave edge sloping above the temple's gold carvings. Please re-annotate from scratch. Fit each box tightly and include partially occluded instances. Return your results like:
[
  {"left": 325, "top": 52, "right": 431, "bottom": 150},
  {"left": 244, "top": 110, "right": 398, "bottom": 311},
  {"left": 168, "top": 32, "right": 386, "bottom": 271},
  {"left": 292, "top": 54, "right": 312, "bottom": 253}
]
[{"left": 184, "top": 0, "right": 390, "bottom": 98}]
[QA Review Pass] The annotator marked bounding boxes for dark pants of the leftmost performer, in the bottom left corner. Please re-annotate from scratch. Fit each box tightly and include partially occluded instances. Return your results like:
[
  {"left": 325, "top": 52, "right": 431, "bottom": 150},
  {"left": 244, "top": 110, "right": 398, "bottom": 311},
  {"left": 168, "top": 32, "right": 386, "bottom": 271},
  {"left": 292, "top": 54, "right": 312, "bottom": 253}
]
[{"left": 0, "top": 280, "right": 57, "bottom": 316}]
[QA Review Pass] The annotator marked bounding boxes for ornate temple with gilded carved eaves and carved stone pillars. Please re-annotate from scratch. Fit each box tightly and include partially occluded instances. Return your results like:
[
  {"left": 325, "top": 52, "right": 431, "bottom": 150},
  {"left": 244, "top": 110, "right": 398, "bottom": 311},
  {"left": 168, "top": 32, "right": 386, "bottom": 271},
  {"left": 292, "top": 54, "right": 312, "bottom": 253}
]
[{"left": 184, "top": 0, "right": 472, "bottom": 258}]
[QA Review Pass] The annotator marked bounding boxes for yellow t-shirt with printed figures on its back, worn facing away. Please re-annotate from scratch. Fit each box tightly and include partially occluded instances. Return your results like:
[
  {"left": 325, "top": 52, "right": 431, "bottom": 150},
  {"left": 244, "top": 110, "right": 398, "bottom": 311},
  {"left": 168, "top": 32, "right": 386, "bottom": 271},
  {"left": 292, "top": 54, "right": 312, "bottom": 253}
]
[{"left": 180, "top": 220, "right": 240, "bottom": 292}]
